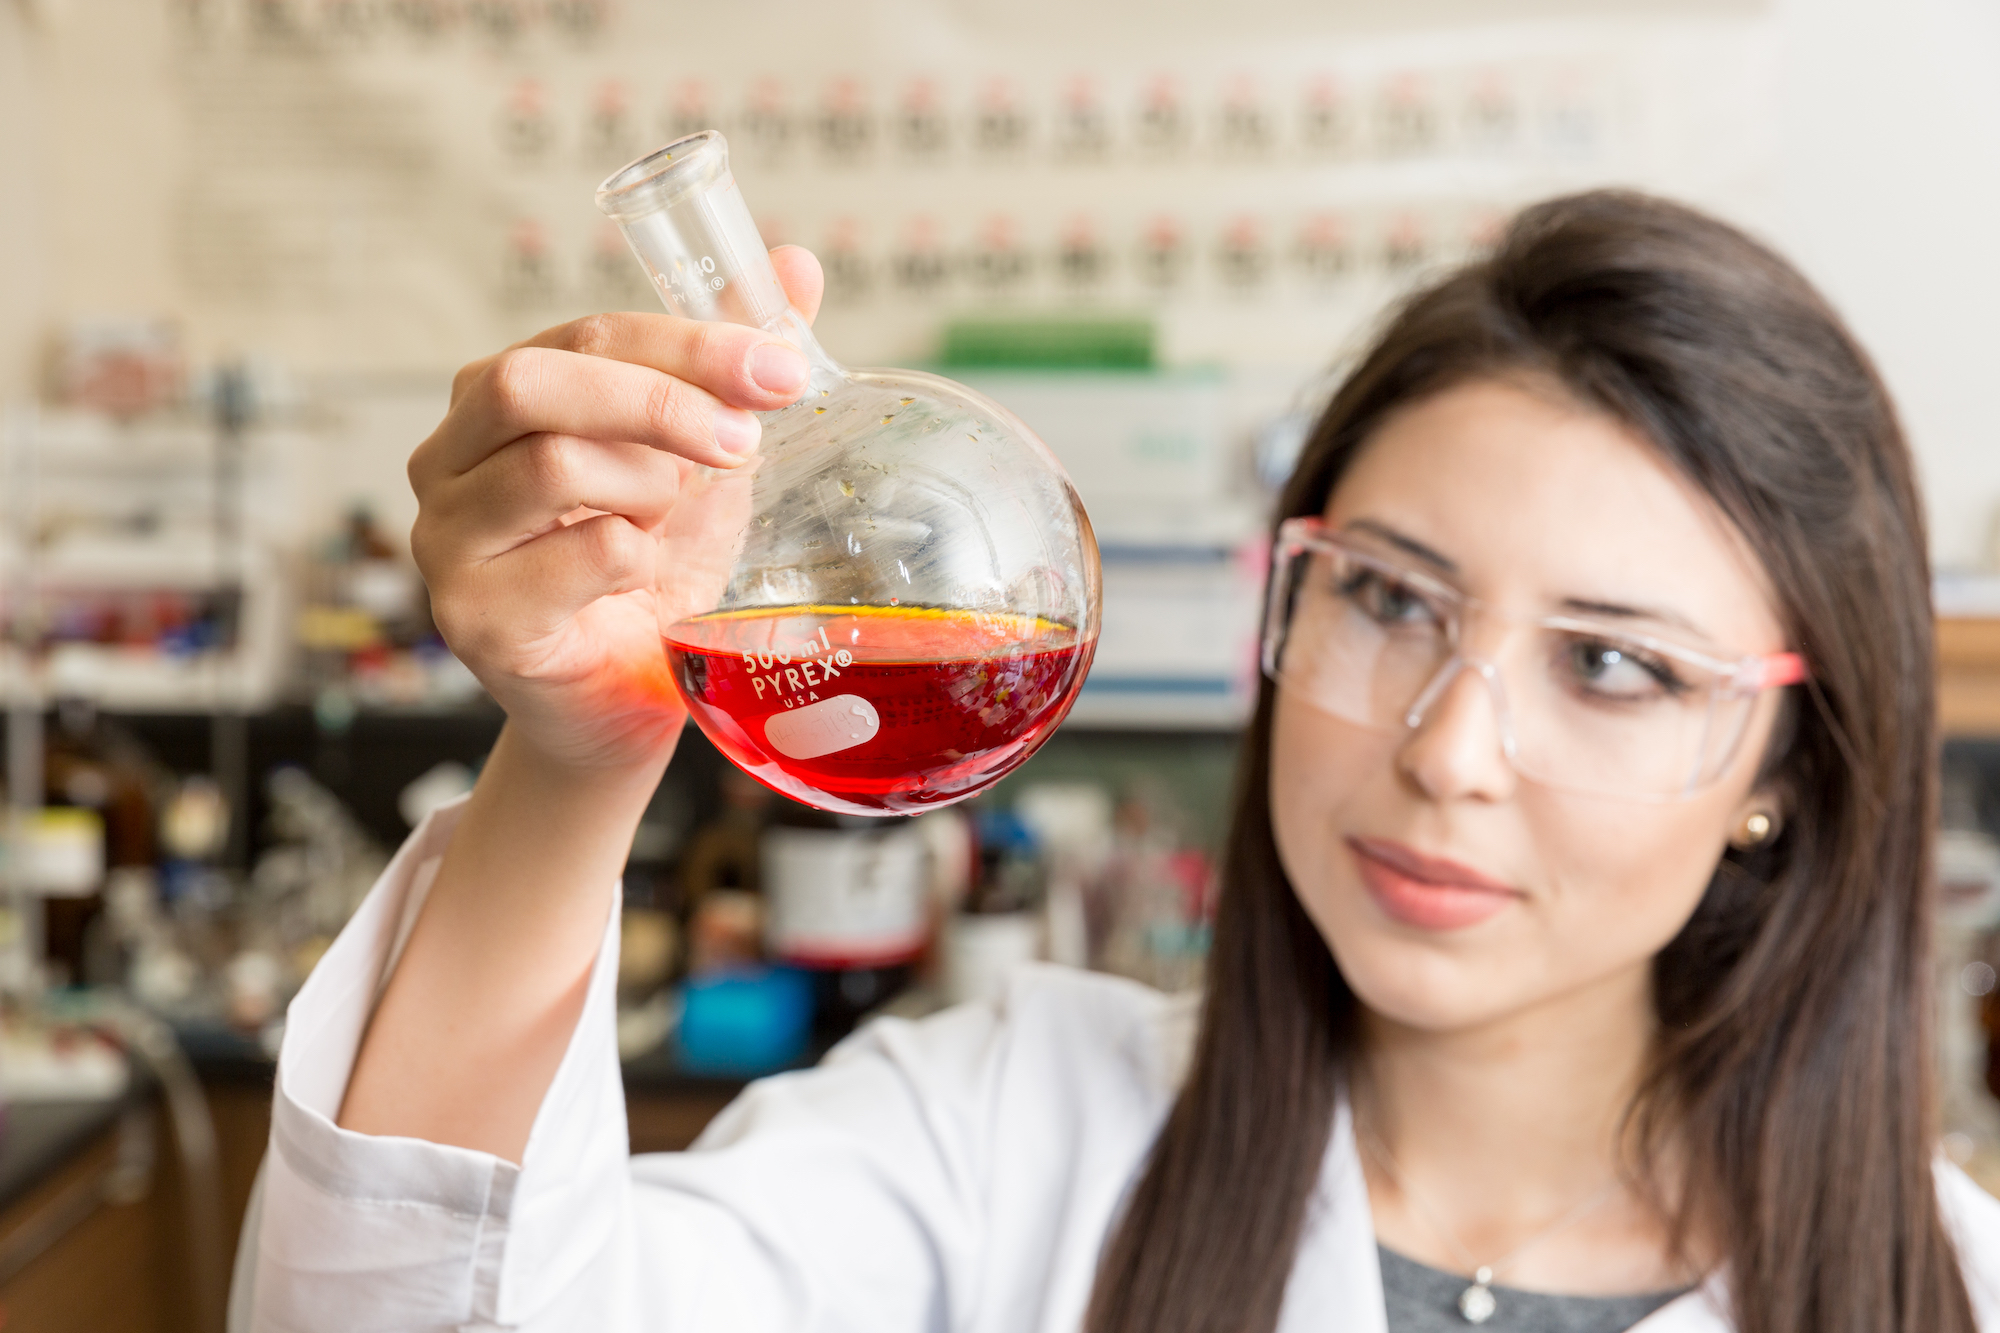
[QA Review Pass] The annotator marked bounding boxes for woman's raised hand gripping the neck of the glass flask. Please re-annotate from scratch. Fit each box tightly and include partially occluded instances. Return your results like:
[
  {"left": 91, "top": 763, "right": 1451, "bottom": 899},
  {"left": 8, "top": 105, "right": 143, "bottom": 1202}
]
[{"left": 410, "top": 246, "right": 820, "bottom": 769}]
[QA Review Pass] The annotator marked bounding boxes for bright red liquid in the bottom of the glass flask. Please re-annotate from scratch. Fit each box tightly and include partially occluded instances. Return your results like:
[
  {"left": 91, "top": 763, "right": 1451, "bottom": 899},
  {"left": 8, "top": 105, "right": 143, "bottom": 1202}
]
[{"left": 666, "top": 606, "right": 1096, "bottom": 815}]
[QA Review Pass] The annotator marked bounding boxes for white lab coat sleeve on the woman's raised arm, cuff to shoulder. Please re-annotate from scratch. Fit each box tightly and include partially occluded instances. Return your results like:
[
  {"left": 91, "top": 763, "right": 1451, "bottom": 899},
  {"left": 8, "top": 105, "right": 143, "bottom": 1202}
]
[{"left": 232, "top": 788, "right": 1006, "bottom": 1333}]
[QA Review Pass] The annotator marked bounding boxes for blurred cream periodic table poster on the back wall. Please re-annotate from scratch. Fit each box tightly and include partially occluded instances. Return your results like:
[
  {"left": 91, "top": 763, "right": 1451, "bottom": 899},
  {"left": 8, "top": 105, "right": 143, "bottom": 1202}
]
[{"left": 156, "top": 0, "right": 1774, "bottom": 374}]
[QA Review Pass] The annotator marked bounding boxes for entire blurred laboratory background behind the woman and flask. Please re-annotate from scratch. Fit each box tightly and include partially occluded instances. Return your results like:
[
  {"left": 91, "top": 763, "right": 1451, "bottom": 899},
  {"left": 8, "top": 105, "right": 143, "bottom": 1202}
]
[{"left": 0, "top": 0, "right": 2000, "bottom": 1333}]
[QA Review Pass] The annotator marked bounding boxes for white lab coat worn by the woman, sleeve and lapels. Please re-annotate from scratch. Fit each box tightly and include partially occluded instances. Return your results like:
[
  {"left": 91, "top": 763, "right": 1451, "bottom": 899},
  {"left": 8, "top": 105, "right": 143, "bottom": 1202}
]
[{"left": 230, "top": 792, "right": 2000, "bottom": 1333}]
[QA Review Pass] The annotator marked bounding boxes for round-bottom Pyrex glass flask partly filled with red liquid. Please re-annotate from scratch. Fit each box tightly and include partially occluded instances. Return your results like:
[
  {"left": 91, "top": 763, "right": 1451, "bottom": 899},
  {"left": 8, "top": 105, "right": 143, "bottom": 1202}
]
[{"left": 598, "top": 132, "right": 1100, "bottom": 815}]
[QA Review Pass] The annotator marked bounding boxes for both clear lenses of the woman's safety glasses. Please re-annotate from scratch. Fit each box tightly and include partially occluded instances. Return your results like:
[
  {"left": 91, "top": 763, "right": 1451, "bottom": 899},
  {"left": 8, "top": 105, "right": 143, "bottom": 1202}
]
[{"left": 1264, "top": 528, "right": 1756, "bottom": 801}]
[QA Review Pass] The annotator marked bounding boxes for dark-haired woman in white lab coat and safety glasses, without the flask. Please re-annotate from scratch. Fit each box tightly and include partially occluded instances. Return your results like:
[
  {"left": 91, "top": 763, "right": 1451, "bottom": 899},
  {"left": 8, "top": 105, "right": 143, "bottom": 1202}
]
[{"left": 236, "top": 194, "right": 2000, "bottom": 1333}]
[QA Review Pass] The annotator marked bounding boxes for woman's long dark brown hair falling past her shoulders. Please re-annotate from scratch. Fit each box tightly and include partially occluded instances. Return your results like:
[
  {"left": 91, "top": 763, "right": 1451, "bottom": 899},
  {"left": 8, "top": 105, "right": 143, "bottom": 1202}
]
[{"left": 1088, "top": 190, "right": 1972, "bottom": 1333}]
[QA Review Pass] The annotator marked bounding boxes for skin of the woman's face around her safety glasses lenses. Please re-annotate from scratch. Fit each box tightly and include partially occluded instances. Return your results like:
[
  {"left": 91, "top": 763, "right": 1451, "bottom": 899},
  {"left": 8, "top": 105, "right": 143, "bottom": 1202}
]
[{"left": 1270, "top": 380, "right": 1786, "bottom": 1033}]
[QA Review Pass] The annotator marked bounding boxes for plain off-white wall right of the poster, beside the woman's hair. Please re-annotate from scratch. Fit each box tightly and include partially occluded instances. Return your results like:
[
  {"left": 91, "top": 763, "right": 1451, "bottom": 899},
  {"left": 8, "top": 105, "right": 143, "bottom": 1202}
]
[{"left": 1774, "top": 0, "right": 2000, "bottom": 566}]
